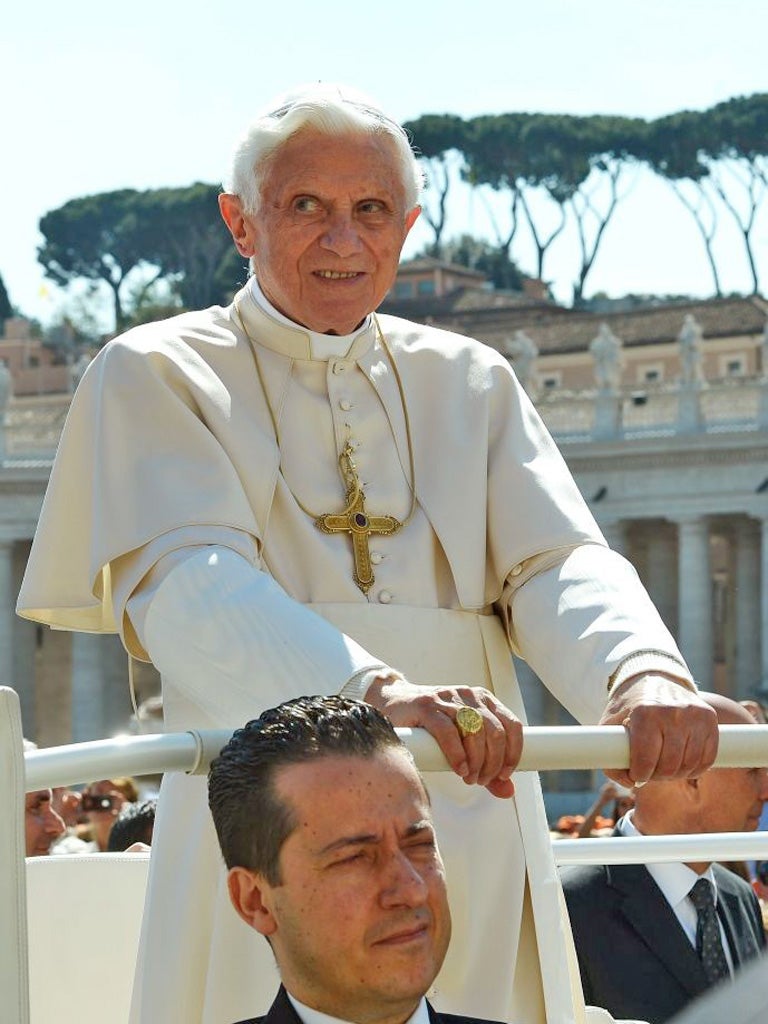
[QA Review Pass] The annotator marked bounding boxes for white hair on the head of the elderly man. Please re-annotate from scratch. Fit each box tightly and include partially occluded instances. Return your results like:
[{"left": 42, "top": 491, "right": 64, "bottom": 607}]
[{"left": 224, "top": 83, "right": 424, "bottom": 215}]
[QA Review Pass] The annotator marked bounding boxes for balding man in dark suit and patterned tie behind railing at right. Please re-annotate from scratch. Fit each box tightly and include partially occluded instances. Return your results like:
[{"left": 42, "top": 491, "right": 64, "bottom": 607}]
[{"left": 562, "top": 694, "right": 768, "bottom": 1024}]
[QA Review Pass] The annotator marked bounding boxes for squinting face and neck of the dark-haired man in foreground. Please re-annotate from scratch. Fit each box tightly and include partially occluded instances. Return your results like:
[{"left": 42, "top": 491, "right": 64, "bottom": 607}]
[{"left": 229, "top": 750, "right": 451, "bottom": 1021}]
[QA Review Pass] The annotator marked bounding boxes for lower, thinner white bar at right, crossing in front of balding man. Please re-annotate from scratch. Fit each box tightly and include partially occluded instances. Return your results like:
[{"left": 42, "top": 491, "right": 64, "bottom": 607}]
[{"left": 552, "top": 831, "right": 768, "bottom": 864}]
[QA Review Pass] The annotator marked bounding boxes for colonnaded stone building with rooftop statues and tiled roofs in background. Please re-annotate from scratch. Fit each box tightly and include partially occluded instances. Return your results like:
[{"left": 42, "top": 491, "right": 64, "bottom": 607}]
[{"left": 0, "top": 268, "right": 768, "bottom": 811}]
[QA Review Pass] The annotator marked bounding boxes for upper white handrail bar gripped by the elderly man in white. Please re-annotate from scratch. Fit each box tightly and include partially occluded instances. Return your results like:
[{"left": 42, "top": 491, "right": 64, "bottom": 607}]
[{"left": 25, "top": 725, "right": 768, "bottom": 792}]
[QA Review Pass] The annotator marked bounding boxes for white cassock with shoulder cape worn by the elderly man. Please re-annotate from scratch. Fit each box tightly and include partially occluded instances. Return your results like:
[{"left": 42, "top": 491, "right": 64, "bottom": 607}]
[{"left": 18, "top": 283, "right": 690, "bottom": 1024}]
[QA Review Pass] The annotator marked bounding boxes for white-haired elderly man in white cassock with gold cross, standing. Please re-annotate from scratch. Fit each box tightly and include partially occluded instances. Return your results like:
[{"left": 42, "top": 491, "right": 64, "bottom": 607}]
[{"left": 18, "top": 86, "right": 717, "bottom": 1024}]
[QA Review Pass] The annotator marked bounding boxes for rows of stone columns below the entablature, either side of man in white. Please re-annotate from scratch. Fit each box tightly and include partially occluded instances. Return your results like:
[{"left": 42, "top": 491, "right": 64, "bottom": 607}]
[{"left": 0, "top": 514, "right": 768, "bottom": 745}]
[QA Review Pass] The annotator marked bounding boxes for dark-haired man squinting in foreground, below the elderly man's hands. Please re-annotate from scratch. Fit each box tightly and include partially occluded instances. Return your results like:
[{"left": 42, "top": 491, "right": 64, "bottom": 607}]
[{"left": 209, "top": 696, "right": 505, "bottom": 1024}]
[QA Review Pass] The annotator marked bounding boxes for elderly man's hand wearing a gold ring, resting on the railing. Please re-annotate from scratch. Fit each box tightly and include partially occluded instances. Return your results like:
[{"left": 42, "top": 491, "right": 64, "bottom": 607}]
[{"left": 366, "top": 679, "right": 522, "bottom": 798}]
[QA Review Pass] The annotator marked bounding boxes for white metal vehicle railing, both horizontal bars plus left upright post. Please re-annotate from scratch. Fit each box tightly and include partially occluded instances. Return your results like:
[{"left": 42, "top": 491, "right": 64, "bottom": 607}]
[{"left": 0, "top": 687, "right": 768, "bottom": 1024}]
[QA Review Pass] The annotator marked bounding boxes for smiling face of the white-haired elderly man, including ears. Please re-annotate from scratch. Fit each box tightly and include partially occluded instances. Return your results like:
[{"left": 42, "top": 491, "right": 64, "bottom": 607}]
[{"left": 221, "top": 129, "right": 419, "bottom": 334}]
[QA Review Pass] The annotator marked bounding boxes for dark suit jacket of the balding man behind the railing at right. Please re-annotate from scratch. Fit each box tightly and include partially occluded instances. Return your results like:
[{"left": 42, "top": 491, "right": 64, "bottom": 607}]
[{"left": 561, "top": 864, "right": 765, "bottom": 1024}]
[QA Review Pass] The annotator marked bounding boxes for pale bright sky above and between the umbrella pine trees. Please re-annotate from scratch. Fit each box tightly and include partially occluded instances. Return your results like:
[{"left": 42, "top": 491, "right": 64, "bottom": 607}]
[{"left": 0, "top": 0, "right": 768, "bottom": 319}]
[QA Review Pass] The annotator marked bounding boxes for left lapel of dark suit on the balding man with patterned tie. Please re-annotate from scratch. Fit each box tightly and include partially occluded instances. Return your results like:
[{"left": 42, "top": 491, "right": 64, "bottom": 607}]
[{"left": 606, "top": 864, "right": 707, "bottom": 995}]
